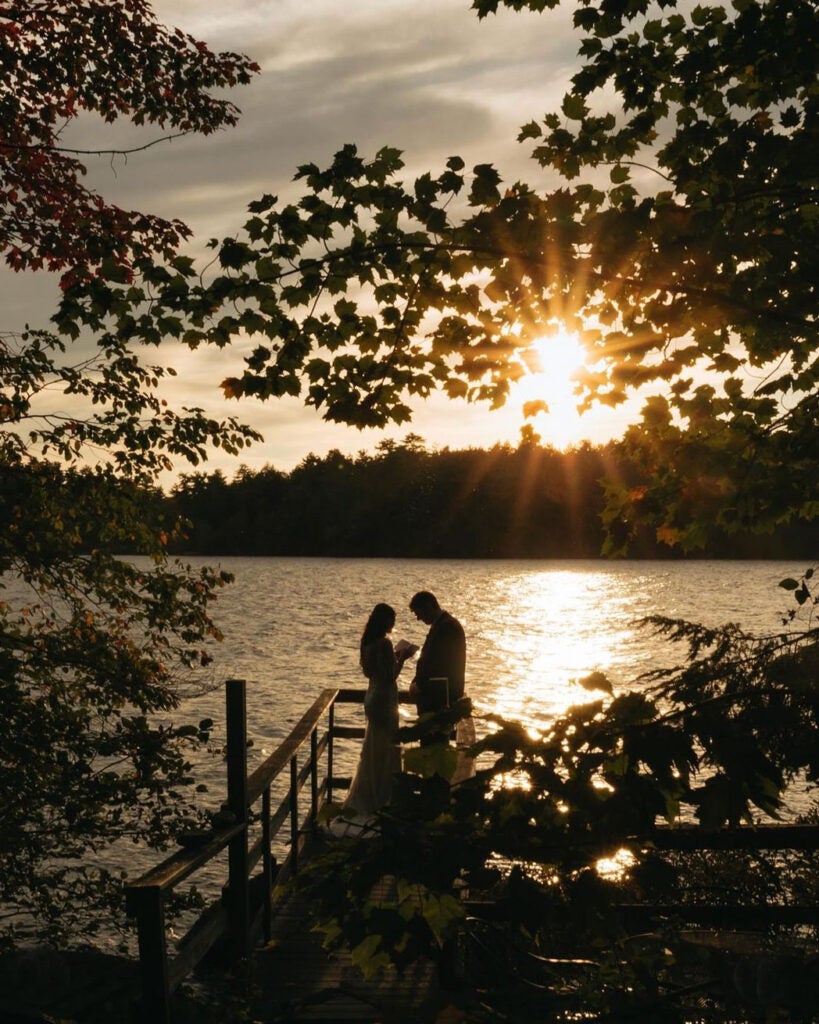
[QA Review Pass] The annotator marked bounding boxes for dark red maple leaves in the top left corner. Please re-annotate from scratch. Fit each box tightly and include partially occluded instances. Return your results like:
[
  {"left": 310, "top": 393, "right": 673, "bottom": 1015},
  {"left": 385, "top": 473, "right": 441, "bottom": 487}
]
[{"left": 0, "top": 0, "right": 259, "bottom": 286}]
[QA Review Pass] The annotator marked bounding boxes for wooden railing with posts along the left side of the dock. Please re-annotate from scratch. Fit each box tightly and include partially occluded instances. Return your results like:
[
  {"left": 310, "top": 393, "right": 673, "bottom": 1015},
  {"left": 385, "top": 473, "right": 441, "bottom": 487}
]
[{"left": 125, "top": 679, "right": 364, "bottom": 1024}]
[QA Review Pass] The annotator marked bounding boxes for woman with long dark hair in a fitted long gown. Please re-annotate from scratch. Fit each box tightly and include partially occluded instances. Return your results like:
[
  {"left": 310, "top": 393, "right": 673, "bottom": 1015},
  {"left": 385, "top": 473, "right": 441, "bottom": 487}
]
[{"left": 344, "top": 604, "right": 418, "bottom": 815}]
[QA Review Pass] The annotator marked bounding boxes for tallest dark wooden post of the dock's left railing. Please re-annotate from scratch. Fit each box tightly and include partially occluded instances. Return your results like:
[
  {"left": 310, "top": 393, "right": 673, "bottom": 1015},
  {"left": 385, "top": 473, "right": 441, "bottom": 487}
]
[{"left": 225, "top": 679, "right": 250, "bottom": 959}]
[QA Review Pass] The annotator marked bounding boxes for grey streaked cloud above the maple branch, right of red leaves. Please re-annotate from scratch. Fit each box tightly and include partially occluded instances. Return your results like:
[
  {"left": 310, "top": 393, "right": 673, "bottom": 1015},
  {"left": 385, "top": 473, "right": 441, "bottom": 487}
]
[{"left": 60, "top": 0, "right": 576, "bottom": 233}]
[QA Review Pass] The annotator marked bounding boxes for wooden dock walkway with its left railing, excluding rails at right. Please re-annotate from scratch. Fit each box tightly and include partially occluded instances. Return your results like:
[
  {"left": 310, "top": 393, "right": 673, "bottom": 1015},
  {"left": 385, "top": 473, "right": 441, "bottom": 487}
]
[{"left": 126, "top": 680, "right": 448, "bottom": 1024}]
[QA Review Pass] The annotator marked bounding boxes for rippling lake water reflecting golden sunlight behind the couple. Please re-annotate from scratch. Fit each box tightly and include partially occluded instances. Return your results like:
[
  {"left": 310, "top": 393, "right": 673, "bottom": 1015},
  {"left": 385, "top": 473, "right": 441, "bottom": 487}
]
[{"left": 190, "top": 558, "right": 806, "bottom": 759}]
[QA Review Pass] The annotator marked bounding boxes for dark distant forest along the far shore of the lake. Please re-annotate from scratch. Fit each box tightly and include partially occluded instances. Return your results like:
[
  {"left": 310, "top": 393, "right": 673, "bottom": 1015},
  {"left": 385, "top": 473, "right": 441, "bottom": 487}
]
[{"left": 162, "top": 434, "right": 817, "bottom": 559}]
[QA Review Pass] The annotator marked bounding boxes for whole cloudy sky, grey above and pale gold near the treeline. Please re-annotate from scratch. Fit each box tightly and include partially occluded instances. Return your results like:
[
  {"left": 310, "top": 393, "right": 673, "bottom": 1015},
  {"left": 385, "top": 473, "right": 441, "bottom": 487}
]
[{"left": 0, "top": 0, "right": 638, "bottom": 475}]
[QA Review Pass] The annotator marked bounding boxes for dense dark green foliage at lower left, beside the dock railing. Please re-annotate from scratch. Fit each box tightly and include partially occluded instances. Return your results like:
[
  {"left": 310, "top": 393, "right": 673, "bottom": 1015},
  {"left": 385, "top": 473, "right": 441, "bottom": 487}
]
[{"left": 0, "top": 462, "right": 229, "bottom": 941}]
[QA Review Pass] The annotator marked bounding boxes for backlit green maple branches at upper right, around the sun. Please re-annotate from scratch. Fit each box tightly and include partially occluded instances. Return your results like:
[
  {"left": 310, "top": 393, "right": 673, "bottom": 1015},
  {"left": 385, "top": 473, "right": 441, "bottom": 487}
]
[{"left": 60, "top": 0, "right": 819, "bottom": 551}]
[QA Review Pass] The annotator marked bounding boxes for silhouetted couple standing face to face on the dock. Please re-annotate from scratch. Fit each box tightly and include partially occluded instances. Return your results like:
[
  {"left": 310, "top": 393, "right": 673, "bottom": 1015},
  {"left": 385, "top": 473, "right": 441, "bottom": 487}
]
[{"left": 344, "top": 590, "right": 467, "bottom": 815}]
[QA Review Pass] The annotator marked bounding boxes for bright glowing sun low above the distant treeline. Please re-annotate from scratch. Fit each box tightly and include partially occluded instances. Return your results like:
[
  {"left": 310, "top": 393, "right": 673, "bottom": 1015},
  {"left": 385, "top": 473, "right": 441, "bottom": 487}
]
[{"left": 510, "top": 331, "right": 588, "bottom": 449}]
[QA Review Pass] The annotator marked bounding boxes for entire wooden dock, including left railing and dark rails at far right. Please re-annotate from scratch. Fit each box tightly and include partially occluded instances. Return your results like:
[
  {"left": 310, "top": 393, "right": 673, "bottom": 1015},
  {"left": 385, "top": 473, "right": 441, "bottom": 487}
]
[{"left": 118, "top": 680, "right": 819, "bottom": 1024}]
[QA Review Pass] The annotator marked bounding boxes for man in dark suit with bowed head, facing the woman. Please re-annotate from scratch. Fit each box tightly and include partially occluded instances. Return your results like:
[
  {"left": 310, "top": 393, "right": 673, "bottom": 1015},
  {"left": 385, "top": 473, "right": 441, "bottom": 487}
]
[{"left": 410, "top": 590, "right": 467, "bottom": 715}]
